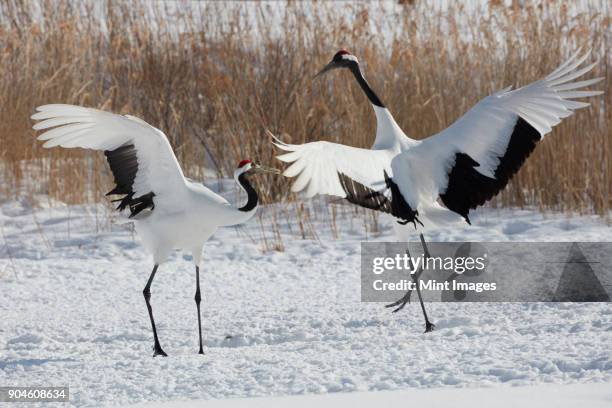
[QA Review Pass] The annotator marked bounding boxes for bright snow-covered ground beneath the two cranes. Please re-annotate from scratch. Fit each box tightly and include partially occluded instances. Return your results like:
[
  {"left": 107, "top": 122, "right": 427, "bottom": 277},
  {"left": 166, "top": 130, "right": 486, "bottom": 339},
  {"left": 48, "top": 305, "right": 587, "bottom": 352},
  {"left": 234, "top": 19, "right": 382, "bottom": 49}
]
[{"left": 0, "top": 195, "right": 612, "bottom": 407}]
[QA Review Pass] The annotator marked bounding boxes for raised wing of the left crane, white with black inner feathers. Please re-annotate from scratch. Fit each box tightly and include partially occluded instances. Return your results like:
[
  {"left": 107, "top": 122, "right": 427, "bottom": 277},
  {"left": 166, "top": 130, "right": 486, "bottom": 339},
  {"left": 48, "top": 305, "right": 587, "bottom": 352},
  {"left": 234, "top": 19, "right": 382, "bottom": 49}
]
[{"left": 32, "top": 104, "right": 185, "bottom": 217}]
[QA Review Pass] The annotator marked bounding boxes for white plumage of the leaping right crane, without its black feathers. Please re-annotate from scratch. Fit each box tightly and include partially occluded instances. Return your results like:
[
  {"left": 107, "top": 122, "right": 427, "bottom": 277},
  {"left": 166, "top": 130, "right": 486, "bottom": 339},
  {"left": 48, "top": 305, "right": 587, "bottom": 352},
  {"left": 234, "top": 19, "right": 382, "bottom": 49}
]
[{"left": 275, "top": 48, "right": 603, "bottom": 230}]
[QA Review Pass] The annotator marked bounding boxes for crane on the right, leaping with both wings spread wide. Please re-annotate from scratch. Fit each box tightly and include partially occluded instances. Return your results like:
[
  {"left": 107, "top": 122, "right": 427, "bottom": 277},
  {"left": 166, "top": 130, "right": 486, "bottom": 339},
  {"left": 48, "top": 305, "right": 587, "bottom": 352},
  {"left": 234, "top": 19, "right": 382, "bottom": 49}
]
[{"left": 275, "top": 50, "right": 603, "bottom": 332}]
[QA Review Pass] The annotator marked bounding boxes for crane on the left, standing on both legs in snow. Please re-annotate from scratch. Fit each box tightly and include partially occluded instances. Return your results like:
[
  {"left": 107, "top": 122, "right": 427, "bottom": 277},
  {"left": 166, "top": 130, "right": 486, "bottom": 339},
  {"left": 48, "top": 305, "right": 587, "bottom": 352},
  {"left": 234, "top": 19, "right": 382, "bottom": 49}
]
[{"left": 32, "top": 104, "right": 278, "bottom": 356}]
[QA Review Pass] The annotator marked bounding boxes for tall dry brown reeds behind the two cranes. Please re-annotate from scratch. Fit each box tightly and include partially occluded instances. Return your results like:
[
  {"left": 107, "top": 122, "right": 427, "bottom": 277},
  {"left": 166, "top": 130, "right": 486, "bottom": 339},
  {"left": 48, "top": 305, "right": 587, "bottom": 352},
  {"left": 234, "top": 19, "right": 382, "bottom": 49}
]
[{"left": 0, "top": 0, "right": 612, "bottom": 225}]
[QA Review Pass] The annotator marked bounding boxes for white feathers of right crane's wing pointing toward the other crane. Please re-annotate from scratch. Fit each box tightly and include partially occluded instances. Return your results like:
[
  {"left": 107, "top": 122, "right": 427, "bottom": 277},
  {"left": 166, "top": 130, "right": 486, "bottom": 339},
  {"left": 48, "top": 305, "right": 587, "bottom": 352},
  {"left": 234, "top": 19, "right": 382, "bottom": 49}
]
[{"left": 272, "top": 135, "right": 393, "bottom": 198}]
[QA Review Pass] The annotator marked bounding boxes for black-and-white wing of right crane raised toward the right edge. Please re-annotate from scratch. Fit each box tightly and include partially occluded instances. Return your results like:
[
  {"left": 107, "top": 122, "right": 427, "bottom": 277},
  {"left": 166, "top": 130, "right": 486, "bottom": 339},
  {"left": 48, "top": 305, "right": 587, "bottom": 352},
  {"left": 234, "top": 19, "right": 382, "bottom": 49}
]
[{"left": 391, "top": 49, "right": 603, "bottom": 222}]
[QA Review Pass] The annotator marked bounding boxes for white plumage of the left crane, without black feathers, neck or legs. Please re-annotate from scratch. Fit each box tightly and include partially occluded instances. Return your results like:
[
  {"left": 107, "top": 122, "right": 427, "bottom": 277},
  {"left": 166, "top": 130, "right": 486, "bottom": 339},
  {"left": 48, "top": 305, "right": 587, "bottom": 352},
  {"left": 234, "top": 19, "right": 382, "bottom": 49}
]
[{"left": 32, "top": 104, "right": 257, "bottom": 265}]
